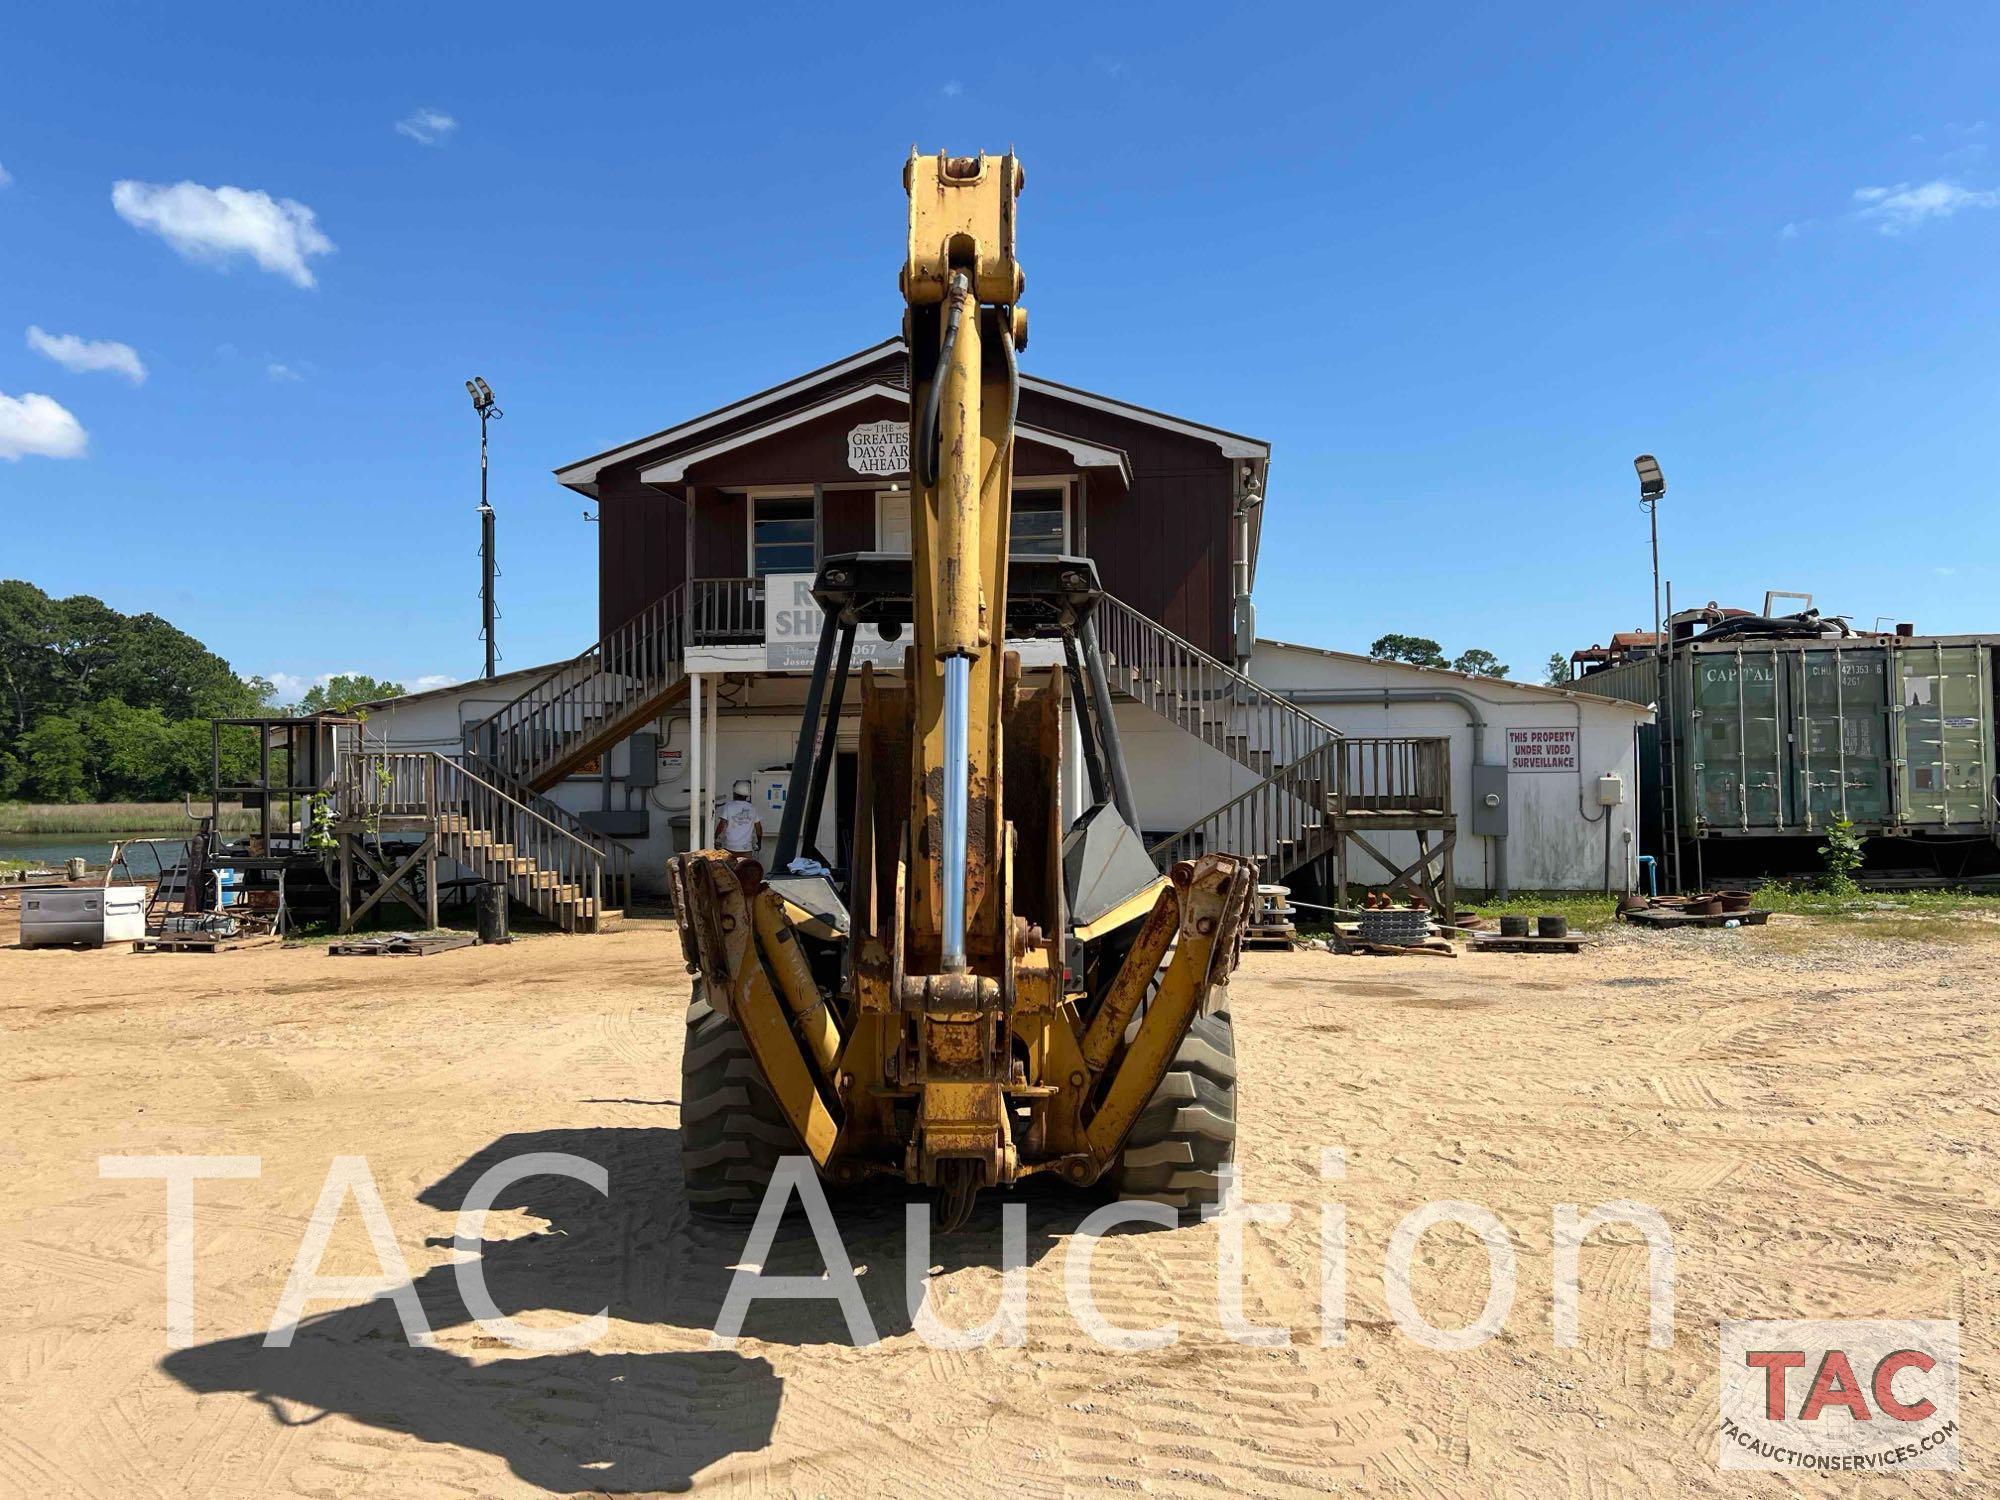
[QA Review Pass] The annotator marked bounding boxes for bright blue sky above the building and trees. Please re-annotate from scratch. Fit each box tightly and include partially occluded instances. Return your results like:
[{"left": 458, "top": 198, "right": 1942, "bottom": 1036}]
[{"left": 0, "top": 4, "right": 2000, "bottom": 682}]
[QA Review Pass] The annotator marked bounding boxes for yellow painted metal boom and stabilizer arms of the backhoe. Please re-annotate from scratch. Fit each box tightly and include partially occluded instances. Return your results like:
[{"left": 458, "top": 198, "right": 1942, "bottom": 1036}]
[{"left": 670, "top": 156, "right": 1254, "bottom": 1216}]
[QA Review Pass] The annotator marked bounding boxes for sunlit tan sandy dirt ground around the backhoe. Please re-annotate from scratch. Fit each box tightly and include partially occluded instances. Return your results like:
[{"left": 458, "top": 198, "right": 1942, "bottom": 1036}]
[{"left": 0, "top": 922, "right": 2000, "bottom": 1498}]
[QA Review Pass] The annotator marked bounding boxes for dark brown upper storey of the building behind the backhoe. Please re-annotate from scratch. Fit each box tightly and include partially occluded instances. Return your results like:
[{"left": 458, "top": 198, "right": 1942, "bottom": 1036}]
[{"left": 556, "top": 338, "right": 1270, "bottom": 660}]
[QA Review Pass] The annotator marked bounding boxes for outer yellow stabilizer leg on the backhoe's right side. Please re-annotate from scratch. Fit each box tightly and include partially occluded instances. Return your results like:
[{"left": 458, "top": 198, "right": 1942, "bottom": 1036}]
[{"left": 1084, "top": 854, "right": 1256, "bottom": 1162}]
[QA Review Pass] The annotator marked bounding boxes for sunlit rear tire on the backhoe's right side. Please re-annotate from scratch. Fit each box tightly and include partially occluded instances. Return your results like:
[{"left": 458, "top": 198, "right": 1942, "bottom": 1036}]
[{"left": 1112, "top": 1010, "right": 1236, "bottom": 1218}]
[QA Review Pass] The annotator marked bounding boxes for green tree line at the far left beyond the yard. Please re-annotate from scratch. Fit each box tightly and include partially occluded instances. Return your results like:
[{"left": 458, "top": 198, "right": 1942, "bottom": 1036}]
[{"left": 0, "top": 578, "right": 402, "bottom": 802}]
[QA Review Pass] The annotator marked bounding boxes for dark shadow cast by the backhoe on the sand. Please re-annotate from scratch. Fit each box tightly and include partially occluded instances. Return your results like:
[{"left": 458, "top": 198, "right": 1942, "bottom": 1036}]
[{"left": 162, "top": 1128, "right": 1092, "bottom": 1494}]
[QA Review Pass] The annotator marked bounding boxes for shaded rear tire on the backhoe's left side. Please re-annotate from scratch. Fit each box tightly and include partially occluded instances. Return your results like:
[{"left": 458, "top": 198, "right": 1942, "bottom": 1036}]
[{"left": 680, "top": 980, "right": 798, "bottom": 1220}]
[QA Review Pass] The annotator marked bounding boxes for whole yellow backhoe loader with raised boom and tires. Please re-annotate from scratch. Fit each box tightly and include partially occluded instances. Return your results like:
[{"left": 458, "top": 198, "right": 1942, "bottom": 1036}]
[{"left": 668, "top": 152, "right": 1256, "bottom": 1230}]
